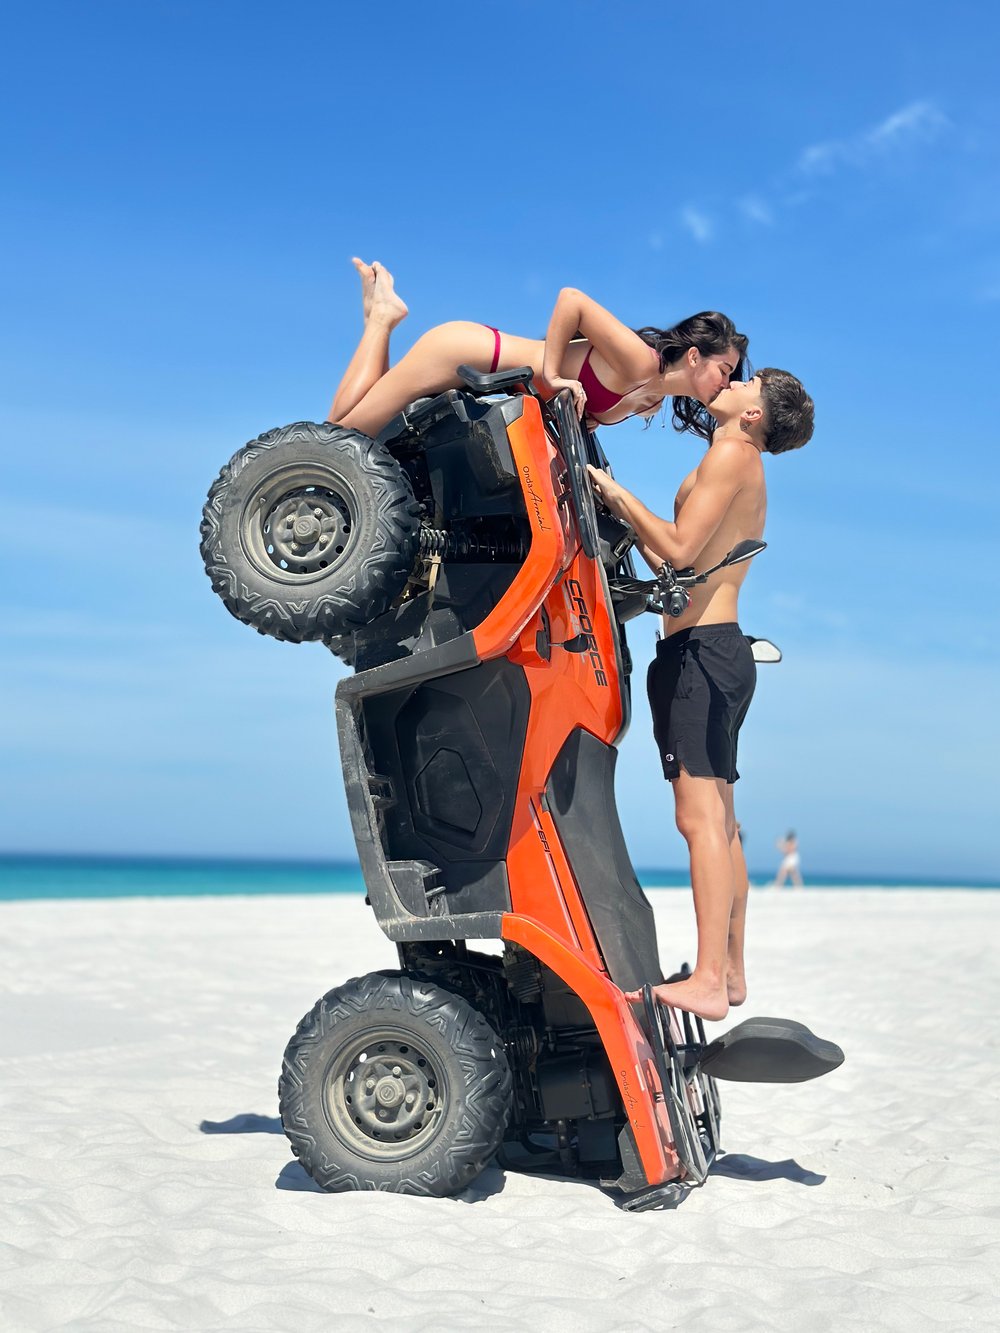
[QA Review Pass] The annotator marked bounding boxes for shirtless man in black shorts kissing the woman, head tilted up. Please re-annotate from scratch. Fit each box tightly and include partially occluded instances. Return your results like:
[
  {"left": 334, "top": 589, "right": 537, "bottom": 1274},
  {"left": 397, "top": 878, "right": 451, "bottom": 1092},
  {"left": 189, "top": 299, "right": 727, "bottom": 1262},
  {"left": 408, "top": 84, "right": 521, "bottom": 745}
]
[{"left": 589, "top": 369, "right": 813, "bottom": 1018}]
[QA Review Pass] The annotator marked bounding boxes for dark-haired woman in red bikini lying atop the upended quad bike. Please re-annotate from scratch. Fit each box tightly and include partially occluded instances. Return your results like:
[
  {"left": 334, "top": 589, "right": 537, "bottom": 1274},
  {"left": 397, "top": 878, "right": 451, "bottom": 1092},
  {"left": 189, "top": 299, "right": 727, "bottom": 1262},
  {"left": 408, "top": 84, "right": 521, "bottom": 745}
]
[{"left": 328, "top": 259, "right": 748, "bottom": 439}]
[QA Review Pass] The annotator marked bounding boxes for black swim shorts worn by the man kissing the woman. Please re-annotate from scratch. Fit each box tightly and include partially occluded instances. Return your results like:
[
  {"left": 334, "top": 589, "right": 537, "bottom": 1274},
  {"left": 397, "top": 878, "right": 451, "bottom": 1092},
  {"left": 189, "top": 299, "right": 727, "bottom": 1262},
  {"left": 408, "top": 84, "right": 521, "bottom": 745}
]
[{"left": 647, "top": 621, "right": 757, "bottom": 782}]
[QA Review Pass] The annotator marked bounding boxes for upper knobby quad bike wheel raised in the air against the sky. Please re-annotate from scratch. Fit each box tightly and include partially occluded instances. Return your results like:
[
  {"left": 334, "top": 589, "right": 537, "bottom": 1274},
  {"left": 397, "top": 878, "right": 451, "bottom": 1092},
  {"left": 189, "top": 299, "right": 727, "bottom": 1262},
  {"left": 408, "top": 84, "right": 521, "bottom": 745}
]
[{"left": 201, "top": 421, "right": 420, "bottom": 643}]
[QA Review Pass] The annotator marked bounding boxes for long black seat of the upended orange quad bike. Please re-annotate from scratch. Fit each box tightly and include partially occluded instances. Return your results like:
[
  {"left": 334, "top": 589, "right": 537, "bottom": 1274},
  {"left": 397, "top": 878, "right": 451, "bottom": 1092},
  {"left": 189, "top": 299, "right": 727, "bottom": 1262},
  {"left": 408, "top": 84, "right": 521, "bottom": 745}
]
[{"left": 545, "top": 728, "right": 663, "bottom": 990}]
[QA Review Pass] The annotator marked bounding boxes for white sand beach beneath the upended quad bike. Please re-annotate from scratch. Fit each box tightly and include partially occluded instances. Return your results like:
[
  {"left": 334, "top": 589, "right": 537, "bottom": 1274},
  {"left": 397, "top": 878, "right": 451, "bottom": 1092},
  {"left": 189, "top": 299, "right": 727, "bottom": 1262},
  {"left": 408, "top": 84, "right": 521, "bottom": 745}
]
[{"left": 0, "top": 889, "right": 1000, "bottom": 1333}]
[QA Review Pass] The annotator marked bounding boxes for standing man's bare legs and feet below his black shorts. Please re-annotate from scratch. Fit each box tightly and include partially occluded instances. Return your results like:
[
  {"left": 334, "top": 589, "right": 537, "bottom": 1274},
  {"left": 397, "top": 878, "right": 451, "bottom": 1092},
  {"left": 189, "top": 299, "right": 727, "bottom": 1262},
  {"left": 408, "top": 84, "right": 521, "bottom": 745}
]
[{"left": 642, "top": 769, "right": 747, "bottom": 1018}]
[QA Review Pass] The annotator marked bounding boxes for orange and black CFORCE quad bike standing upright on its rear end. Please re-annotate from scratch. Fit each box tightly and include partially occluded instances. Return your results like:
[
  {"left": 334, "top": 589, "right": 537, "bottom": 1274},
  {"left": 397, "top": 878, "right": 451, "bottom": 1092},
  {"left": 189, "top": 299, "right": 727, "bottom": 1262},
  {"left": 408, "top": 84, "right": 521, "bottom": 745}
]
[{"left": 201, "top": 367, "right": 843, "bottom": 1209}]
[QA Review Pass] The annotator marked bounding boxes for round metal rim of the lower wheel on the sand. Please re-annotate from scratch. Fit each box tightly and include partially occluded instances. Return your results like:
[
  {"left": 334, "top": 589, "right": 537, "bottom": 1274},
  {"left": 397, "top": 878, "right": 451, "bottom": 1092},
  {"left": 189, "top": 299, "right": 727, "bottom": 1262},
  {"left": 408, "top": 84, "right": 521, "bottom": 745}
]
[{"left": 324, "top": 1028, "right": 448, "bottom": 1161}]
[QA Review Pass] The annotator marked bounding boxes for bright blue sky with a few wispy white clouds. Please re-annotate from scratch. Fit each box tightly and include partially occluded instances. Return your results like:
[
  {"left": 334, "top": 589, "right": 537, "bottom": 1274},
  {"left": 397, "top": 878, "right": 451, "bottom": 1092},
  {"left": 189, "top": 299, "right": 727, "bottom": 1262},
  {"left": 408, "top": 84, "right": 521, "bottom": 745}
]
[{"left": 0, "top": 0, "right": 1000, "bottom": 880}]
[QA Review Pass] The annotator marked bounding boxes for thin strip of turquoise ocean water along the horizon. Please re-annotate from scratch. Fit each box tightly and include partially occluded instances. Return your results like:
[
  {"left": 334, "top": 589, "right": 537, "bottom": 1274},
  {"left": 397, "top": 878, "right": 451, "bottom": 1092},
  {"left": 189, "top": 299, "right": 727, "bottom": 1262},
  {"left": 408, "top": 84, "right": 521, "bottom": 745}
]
[{"left": 0, "top": 856, "right": 999, "bottom": 902}]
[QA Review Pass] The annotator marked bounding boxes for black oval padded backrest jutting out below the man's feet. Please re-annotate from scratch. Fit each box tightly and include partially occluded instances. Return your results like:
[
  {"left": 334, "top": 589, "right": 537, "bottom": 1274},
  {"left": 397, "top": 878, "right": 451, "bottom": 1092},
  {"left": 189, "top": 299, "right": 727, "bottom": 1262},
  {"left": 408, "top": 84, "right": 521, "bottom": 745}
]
[{"left": 699, "top": 1018, "right": 844, "bottom": 1082}]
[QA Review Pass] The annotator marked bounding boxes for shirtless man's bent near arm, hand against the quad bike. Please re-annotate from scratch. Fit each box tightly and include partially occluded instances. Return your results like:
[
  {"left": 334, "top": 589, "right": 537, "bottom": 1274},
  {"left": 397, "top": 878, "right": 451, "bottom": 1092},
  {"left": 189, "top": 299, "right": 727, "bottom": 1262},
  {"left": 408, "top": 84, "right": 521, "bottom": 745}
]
[{"left": 588, "top": 440, "right": 748, "bottom": 569}]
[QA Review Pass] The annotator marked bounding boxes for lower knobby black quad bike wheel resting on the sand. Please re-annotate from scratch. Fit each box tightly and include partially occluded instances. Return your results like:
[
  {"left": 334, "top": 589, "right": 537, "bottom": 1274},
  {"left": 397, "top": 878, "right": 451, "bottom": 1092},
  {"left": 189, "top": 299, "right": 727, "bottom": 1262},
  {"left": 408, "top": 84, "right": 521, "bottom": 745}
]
[{"left": 279, "top": 973, "right": 511, "bottom": 1196}]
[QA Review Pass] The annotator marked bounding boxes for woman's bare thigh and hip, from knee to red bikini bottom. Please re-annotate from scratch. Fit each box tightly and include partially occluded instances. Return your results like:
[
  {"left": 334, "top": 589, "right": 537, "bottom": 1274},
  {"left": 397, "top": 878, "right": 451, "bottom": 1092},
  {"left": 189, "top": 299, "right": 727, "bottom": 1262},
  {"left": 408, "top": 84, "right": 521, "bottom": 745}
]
[{"left": 337, "top": 320, "right": 509, "bottom": 435}]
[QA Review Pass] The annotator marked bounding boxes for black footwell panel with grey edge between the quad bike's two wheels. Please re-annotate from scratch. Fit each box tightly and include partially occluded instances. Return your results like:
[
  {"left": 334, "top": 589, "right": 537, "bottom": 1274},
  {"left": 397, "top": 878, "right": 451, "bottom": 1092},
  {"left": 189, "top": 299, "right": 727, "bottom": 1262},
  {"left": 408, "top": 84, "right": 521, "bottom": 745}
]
[{"left": 337, "top": 635, "right": 531, "bottom": 940}]
